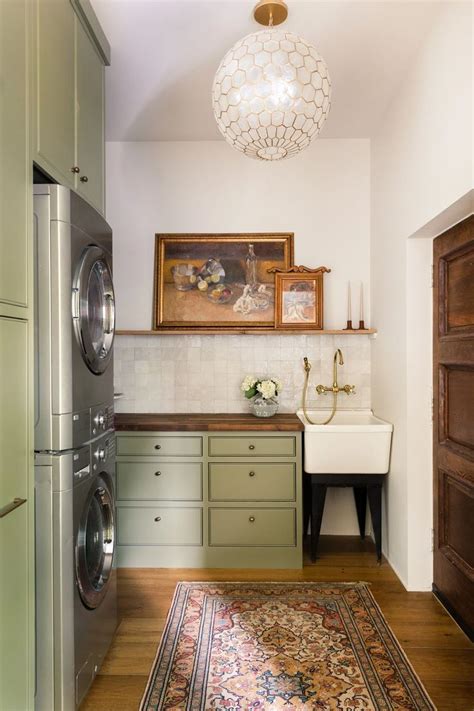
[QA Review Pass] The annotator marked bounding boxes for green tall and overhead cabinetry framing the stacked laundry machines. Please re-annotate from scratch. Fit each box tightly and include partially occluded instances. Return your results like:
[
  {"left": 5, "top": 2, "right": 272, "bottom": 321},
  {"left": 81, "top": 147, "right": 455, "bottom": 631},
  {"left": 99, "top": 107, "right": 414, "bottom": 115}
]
[{"left": 0, "top": 0, "right": 110, "bottom": 711}]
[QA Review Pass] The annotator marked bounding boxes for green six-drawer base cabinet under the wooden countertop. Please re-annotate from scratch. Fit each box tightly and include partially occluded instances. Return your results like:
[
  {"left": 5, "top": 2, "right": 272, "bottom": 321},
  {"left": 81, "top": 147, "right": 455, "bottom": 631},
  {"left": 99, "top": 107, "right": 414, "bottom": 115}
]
[{"left": 116, "top": 432, "right": 302, "bottom": 568}]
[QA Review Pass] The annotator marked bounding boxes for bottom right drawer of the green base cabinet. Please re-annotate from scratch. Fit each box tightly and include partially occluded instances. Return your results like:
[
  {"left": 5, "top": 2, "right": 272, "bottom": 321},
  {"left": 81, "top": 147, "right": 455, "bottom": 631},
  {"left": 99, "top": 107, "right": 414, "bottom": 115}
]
[{"left": 209, "top": 508, "right": 296, "bottom": 546}]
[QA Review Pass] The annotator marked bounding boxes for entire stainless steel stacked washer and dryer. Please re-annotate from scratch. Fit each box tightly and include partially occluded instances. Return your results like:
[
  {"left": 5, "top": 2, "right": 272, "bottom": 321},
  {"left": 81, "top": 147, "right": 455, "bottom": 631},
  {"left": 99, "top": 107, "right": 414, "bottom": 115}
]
[{"left": 34, "top": 185, "right": 117, "bottom": 711}]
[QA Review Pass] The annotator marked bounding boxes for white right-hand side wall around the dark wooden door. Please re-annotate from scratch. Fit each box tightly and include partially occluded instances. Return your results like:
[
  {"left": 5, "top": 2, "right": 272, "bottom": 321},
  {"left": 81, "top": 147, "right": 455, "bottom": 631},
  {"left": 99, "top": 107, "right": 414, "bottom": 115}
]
[{"left": 371, "top": 2, "right": 473, "bottom": 590}]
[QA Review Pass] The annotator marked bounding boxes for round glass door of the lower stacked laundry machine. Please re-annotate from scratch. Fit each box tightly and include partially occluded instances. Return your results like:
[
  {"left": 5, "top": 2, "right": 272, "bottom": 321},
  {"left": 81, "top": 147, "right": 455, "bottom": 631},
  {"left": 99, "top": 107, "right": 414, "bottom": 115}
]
[{"left": 75, "top": 474, "right": 115, "bottom": 609}]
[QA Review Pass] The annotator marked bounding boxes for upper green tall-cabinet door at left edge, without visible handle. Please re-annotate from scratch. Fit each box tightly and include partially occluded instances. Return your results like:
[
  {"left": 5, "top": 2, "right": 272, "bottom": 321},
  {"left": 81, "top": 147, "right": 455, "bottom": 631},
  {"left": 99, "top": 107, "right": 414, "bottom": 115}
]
[{"left": 0, "top": 0, "right": 30, "bottom": 307}]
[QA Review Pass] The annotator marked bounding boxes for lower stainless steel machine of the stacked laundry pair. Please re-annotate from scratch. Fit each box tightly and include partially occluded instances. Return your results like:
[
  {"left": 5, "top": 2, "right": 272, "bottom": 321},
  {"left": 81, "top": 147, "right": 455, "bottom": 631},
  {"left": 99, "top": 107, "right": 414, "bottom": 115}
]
[{"left": 35, "top": 432, "right": 117, "bottom": 711}]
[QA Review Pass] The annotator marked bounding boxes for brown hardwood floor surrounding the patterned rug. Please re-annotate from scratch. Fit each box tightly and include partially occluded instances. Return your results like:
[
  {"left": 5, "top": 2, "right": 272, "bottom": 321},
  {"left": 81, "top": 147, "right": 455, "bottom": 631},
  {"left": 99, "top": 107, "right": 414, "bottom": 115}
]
[{"left": 81, "top": 536, "right": 474, "bottom": 711}]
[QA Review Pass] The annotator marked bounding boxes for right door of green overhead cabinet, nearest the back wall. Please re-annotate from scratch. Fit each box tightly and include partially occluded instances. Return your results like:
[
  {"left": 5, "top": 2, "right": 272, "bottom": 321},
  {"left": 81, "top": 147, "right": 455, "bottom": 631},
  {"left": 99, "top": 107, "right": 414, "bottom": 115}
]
[{"left": 75, "top": 18, "right": 105, "bottom": 213}]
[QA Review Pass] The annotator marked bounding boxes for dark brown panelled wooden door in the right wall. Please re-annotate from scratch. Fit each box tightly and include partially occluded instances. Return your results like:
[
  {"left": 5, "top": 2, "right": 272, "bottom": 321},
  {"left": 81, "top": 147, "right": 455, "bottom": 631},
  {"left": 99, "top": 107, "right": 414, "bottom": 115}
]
[{"left": 433, "top": 215, "right": 474, "bottom": 635}]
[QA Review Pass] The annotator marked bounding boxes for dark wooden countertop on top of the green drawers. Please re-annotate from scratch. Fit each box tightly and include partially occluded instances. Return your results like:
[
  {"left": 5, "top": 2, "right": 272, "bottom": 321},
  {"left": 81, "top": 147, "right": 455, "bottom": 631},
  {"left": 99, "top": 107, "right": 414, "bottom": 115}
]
[{"left": 115, "top": 413, "right": 304, "bottom": 432}]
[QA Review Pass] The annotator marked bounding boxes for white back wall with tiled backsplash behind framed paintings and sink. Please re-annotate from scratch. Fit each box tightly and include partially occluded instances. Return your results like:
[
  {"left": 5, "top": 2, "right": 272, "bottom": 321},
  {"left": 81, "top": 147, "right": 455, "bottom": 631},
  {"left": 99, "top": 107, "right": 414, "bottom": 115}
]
[{"left": 107, "top": 139, "right": 370, "bottom": 534}]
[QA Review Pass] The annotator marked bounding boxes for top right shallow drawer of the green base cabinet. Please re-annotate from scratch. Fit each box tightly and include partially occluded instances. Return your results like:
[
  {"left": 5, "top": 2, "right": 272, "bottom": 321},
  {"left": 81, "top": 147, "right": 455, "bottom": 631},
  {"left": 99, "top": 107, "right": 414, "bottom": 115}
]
[{"left": 209, "top": 436, "right": 296, "bottom": 457}]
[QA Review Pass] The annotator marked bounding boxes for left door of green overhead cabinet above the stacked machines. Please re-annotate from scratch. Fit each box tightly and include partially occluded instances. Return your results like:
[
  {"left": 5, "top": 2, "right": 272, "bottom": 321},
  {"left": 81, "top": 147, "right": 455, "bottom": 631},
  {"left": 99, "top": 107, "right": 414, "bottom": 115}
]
[{"left": 34, "top": 0, "right": 76, "bottom": 187}]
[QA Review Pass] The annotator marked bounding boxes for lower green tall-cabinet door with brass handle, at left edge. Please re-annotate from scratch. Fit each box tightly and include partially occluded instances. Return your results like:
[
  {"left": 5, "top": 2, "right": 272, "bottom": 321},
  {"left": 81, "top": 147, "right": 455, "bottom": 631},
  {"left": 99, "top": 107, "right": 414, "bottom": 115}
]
[{"left": 0, "top": 318, "right": 34, "bottom": 711}]
